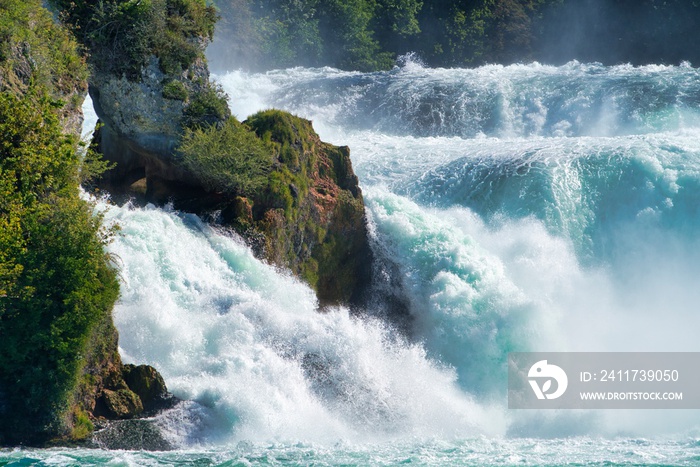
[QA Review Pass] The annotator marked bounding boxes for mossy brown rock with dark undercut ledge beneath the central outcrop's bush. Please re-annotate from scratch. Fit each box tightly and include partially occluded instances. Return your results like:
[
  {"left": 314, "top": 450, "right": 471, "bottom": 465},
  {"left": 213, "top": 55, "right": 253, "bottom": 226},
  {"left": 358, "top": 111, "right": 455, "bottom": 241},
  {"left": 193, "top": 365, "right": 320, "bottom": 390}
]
[{"left": 98, "top": 110, "right": 371, "bottom": 306}]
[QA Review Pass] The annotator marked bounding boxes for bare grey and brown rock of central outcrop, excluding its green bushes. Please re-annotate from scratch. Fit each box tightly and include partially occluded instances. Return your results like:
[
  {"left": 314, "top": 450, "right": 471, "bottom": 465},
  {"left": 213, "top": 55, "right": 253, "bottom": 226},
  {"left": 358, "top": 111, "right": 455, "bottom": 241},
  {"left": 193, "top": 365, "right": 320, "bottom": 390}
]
[{"left": 90, "top": 18, "right": 371, "bottom": 306}]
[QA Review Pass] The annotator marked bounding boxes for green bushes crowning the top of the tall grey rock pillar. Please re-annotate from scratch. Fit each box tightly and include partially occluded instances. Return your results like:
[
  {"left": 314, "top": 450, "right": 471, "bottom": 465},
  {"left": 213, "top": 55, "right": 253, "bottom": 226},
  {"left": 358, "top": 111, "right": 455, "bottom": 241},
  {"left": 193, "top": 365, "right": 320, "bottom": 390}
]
[{"left": 51, "top": 0, "right": 217, "bottom": 78}]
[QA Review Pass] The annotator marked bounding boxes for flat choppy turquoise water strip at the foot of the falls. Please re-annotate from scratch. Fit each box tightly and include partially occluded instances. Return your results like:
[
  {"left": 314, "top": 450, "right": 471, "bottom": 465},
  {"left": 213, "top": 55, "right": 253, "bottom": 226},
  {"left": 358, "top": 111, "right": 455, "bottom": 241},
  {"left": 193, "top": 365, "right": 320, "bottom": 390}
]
[{"left": 0, "top": 438, "right": 700, "bottom": 467}]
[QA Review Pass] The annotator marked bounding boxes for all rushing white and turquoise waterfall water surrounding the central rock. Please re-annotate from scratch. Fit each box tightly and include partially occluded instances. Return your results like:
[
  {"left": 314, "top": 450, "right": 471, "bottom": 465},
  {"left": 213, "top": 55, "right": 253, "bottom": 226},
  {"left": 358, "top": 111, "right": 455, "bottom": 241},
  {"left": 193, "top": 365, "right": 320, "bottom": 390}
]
[{"left": 9, "top": 60, "right": 700, "bottom": 466}]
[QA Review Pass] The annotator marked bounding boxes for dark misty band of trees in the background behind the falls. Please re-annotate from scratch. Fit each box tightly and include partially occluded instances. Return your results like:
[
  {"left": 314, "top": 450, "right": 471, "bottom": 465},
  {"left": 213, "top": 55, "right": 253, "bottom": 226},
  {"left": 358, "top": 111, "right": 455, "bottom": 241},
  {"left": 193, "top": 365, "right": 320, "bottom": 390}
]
[{"left": 217, "top": 0, "right": 700, "bottom": 71}]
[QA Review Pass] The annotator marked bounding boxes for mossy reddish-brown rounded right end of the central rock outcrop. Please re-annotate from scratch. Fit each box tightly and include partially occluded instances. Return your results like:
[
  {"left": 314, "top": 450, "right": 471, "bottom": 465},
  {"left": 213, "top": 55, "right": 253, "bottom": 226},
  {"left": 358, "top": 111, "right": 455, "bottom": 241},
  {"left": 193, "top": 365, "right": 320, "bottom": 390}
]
[{"left": 241, "top": 110, "right": 371, "bottom": 305}]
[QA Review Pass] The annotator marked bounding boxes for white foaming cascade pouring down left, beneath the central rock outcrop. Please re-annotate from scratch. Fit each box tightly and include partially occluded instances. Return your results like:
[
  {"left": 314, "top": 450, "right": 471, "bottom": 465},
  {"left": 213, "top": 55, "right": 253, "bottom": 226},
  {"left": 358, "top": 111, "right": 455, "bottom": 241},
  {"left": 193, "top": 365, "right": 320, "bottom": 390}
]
[{"left": 101, "top": 205, "right": 503, "bottom": 444}]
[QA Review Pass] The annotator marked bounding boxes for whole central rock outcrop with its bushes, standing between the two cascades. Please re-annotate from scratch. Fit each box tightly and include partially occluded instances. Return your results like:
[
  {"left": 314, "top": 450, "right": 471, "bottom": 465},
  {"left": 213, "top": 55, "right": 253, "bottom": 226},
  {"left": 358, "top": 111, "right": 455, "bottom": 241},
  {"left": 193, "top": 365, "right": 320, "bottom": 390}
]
[{"left": 74, "top": 0, "right": 370, "bottom": 305}]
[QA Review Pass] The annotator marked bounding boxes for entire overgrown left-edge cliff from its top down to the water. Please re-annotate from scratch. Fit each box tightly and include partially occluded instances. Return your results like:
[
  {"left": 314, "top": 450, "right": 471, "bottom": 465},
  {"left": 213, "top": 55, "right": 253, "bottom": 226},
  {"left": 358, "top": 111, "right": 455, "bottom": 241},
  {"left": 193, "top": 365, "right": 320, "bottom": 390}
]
[{"left": 0, "top": 0, "right": 119, "bottom": 444}]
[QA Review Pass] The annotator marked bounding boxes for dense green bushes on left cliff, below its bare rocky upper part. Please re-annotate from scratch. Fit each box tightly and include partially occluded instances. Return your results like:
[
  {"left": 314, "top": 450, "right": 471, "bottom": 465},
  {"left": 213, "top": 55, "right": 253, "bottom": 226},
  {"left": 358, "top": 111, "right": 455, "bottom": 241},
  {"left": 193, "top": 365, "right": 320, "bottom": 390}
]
[{"left": 0, "top": 90, "right": 119, "bottom": 443}]
